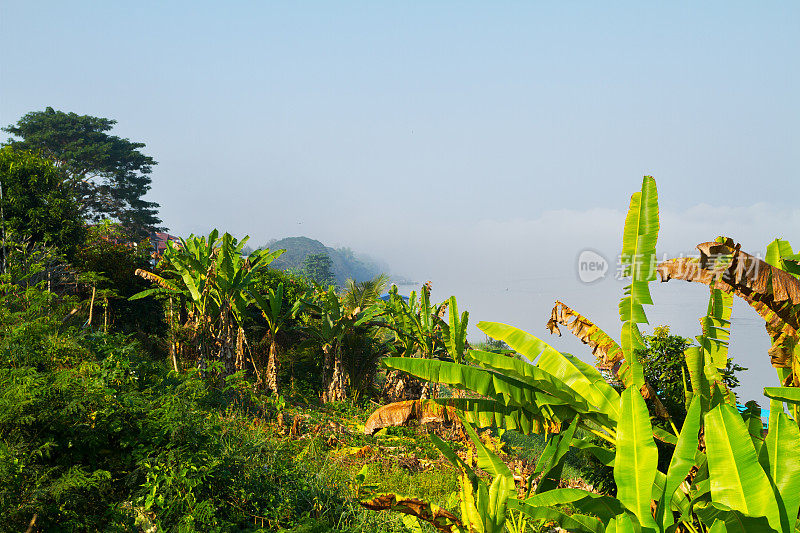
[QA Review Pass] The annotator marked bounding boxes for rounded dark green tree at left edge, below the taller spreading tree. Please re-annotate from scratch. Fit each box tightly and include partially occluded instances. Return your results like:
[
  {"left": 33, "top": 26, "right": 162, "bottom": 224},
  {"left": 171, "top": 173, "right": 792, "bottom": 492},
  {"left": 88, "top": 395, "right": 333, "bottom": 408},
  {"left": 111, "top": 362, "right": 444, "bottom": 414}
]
[{"left": 0, "top": 146, "right": 85, "bottom": 257}]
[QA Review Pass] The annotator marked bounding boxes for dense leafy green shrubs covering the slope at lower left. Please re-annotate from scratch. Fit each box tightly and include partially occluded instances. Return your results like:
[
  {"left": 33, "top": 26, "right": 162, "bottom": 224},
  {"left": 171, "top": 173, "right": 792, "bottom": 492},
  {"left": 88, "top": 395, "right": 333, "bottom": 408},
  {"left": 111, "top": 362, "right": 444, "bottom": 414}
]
[{"left": 0, "top": 272, "right": 422, "bottom": 531}]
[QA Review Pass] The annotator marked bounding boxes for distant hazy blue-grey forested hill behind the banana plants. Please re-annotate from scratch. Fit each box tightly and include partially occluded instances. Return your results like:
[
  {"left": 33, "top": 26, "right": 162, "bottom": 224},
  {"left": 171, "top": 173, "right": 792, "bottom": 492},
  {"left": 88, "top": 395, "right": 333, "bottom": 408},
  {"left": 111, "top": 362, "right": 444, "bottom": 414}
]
[{"left": 268, "top": 237, "right": 388, "bottom": 285}]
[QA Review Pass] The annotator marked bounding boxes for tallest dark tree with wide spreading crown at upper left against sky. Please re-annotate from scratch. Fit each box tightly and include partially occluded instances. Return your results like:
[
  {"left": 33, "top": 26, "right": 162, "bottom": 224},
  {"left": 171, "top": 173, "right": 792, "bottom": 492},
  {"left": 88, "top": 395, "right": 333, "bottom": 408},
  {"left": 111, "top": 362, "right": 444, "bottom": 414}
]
[{"left": 3, "top": 107, "right": 161, "bottom": 238}]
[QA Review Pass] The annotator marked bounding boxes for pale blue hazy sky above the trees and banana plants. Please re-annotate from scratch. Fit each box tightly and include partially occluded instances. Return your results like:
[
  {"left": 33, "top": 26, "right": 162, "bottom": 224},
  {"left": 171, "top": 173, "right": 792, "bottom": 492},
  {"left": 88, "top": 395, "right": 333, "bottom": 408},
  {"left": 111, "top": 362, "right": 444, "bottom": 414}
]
[{"left": 0, "top": 0, "right": 800, "bottom": 399}]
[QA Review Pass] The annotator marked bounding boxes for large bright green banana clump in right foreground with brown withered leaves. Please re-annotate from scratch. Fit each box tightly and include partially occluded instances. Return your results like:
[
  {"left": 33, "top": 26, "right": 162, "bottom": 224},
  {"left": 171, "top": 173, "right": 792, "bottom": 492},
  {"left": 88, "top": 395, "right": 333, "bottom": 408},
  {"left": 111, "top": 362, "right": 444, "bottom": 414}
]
[{"left": 374, "top": 178, "right": 800, "bottom": 533}]
